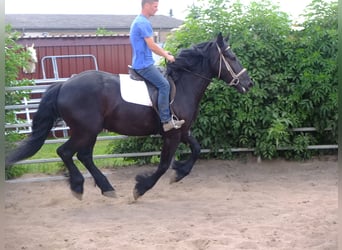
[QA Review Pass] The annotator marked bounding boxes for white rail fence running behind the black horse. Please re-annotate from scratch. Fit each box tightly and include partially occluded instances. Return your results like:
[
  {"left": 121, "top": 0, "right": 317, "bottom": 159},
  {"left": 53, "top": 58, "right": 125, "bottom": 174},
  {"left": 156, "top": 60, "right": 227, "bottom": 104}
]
[{"left": 5, "top": 84, "right": 338, "bottom": 165}]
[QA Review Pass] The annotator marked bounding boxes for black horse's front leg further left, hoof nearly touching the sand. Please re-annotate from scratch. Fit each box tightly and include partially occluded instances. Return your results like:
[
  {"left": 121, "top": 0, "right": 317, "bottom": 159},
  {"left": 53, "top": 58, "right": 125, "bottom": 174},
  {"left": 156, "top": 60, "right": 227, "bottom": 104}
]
[{"left": 133, "top": 131, "right": 181, "bottom": 200}]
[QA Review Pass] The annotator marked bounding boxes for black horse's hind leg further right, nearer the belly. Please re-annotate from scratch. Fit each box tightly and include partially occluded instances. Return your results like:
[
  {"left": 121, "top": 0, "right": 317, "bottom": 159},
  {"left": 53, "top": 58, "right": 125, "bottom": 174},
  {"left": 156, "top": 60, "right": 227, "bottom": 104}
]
[{"left": 77, "top": 137, "right": 116, "bottom": 197}]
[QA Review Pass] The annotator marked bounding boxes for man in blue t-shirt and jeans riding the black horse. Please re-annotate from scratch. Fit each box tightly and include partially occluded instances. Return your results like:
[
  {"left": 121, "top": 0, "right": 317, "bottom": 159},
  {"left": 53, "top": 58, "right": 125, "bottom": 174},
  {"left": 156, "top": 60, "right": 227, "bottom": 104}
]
[{"left": 130, "top": 0, "right": 185, "bottom": 132}]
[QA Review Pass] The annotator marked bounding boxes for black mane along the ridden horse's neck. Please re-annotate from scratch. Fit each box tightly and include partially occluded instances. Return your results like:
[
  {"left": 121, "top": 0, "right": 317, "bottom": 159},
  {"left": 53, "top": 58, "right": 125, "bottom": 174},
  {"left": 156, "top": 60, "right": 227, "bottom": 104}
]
[{"left": 167, "top": 42, "right": 213, "bottom": 81}]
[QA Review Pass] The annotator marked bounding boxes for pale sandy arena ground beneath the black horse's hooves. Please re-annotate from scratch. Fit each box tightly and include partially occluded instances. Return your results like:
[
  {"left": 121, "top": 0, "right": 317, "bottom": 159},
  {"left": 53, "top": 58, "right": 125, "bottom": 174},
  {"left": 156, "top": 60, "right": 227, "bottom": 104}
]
[{"left": 5, "top": 157, "right": 338, "bottom": 250}]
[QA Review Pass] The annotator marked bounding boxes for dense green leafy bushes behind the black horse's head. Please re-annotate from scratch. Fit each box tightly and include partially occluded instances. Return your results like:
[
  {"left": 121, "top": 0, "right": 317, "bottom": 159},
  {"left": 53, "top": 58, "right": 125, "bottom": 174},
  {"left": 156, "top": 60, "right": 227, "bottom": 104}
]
[{"left": 111, "top": 0, "right": 337, "bottom": 159}]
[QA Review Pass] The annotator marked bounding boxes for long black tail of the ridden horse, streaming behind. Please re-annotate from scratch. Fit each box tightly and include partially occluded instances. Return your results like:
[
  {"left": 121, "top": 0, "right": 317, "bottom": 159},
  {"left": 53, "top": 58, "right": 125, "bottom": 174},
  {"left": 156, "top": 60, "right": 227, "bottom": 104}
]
[{"left": 5, "top": 83, "right": 62, "bottom": 167}]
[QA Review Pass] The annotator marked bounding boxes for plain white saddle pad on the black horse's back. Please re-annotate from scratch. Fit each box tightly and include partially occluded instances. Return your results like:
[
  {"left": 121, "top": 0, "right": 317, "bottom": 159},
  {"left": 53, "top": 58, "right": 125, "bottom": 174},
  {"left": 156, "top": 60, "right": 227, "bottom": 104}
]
[{"left": 119, "top": 74, "right": 152, "bottom": 107}]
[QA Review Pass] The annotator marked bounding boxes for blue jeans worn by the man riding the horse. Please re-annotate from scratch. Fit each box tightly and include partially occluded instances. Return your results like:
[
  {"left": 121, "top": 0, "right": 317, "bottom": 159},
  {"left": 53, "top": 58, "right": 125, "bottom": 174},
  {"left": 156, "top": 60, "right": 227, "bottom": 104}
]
[{"left": 135, "top": 65, "right": 171, "bottom": 123}]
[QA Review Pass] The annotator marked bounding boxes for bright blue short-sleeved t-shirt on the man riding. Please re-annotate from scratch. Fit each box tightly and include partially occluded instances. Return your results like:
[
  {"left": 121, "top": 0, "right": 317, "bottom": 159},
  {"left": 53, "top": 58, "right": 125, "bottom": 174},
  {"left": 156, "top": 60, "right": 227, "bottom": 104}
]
[{"left": 130, "top": 15, "right": 154, "bottom": 69}]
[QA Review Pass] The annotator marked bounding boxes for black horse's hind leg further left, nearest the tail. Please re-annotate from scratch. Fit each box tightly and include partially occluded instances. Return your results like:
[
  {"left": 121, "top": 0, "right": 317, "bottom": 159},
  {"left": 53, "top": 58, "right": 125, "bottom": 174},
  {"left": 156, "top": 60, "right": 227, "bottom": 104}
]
[{"left": 57, "top": 140, "right": 84, "bottom": 200}]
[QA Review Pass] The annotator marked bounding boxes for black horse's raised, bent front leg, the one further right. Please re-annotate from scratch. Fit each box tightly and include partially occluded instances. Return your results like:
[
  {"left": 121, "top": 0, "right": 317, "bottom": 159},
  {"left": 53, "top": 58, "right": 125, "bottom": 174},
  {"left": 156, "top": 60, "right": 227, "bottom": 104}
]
[{"left": 170, "top": 131, "right": 201, "bottom": 183}]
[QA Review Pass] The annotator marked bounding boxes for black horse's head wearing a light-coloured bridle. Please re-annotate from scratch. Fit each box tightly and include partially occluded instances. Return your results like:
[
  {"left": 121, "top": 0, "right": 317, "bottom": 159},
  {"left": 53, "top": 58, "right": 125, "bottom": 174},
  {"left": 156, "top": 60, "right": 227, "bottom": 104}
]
[{"left": 214, "top": 33, "right": 253, "bottom": 93}]
